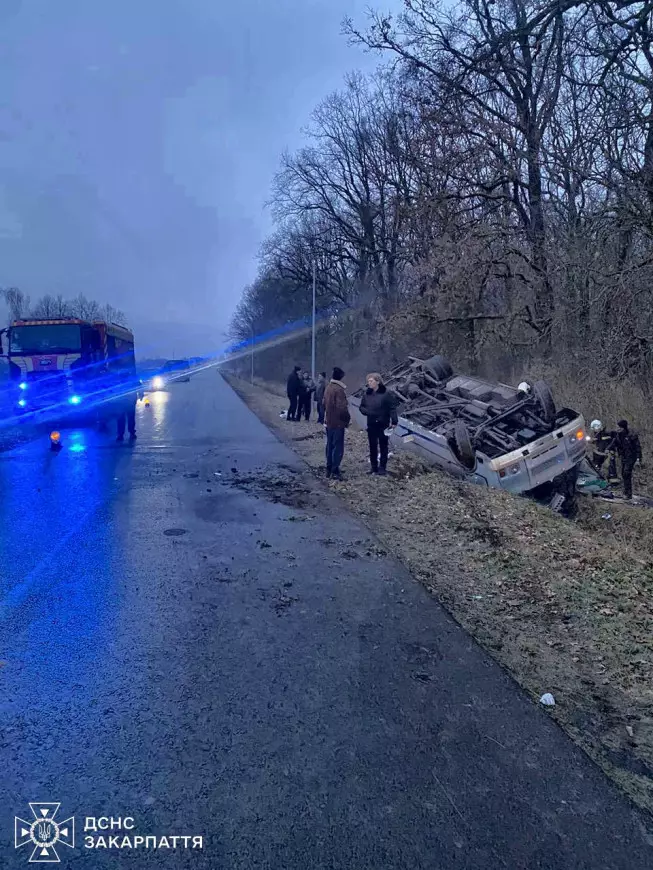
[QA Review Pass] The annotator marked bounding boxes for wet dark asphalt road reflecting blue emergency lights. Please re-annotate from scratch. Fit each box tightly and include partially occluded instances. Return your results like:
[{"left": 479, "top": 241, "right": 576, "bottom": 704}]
[{"left": 0, "top": 371, "right": 653, "bottom": 870}]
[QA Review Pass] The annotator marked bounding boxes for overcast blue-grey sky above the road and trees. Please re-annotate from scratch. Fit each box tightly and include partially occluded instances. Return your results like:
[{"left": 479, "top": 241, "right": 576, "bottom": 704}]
[{"left": 0, "top": 0, "right": 392, "bottom": 356}]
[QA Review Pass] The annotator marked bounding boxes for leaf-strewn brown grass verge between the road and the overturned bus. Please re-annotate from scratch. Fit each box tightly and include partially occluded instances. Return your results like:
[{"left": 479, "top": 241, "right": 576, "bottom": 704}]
[{"left": 230, "top": 379, "right": 653, "bottom": 811}]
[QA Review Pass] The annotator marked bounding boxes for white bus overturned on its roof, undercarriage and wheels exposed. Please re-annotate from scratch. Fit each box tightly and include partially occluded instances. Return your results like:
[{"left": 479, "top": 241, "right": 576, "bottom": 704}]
[{"left": 349, "top": 356, "right": 587, "bottom": 493}]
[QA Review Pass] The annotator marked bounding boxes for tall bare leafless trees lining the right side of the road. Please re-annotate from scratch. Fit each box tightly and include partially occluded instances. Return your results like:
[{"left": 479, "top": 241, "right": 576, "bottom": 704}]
[{"left": 232, "top": 0, "right": 653, "bottom": 389}]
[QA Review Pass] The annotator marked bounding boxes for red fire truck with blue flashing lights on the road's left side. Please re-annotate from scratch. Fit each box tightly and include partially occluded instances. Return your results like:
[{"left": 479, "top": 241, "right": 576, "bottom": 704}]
[{"left": 0, "top": 317, "right": 136, "bottom": 414}]
